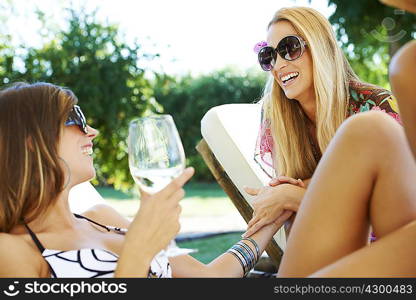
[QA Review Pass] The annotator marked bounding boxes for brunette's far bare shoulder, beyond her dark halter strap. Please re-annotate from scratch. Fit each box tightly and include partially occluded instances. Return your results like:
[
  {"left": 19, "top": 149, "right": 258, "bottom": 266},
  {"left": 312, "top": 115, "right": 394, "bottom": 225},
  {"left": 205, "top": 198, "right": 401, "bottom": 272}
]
[{"left": 83, "top": 204, "right": 130, "bottom": 228}]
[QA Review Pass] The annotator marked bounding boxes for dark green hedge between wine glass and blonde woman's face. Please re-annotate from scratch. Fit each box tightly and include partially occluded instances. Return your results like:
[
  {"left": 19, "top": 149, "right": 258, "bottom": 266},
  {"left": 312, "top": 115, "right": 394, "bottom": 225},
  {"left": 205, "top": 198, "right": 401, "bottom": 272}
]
[{"left": 154, "top": 69, "right": 266, "bottom": 181}]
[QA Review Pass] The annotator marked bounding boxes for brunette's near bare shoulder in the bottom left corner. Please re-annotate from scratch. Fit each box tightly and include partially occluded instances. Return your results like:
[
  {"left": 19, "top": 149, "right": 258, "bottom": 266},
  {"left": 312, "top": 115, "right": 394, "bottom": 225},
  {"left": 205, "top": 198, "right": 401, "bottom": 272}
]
[{"left": 0, "top": 233, "right": 44, "bottom": 277}]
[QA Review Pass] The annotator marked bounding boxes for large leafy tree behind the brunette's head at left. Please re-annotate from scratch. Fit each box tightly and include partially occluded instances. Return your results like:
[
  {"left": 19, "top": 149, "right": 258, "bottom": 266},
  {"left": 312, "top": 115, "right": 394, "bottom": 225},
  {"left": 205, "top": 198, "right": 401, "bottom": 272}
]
[{"left": 0, "top": 10, "right": 155, "bottom": 188}]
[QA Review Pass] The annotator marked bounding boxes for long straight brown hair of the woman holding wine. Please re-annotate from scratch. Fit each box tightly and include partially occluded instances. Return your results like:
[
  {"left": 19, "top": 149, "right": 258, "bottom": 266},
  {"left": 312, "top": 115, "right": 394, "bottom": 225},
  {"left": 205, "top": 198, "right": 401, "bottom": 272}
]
[{"left": 0, "top": 82, "right": 78, "bottom": 232}]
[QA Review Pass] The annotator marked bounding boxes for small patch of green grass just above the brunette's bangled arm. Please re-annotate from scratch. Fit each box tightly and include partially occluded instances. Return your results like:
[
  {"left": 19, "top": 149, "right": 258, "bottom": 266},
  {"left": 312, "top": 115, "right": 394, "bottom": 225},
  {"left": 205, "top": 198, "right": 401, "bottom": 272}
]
[{"left": 177, "top": 233, "right": 241, "bottom": 263}]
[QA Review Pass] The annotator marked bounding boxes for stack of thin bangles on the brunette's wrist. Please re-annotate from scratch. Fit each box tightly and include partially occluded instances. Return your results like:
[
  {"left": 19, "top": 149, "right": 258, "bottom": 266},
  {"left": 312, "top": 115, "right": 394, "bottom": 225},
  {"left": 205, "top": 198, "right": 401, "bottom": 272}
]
[{"left": 227, "top": 238, "right": 260, "bottom": 276}]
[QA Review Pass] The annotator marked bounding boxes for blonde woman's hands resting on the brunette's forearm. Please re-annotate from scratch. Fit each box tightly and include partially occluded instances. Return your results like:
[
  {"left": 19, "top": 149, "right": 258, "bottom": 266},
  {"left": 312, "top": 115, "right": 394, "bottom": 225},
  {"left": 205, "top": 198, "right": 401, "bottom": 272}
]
[{"left": 244, "top": 182, "right": 305, "bottom": 236}]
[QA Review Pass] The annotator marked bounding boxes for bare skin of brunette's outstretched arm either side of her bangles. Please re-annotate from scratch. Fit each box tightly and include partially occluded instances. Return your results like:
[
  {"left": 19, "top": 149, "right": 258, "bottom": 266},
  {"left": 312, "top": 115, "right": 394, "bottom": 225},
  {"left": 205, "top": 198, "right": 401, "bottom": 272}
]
[{"left": 169, "top": 217, "right": 283, "bottom": 278}]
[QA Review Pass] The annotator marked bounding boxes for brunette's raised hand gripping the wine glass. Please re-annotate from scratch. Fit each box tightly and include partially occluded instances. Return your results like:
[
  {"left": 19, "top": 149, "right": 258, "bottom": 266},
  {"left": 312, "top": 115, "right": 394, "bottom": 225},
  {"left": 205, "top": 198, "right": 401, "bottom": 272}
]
[{"left": 126, "top": 168, "right": 194, "bottom": 259}]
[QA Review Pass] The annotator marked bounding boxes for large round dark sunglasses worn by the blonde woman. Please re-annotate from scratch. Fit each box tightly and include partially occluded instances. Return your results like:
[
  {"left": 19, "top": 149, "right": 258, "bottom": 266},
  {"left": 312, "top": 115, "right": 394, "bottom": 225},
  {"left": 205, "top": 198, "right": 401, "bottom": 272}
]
[{"left": 258, "top": 35, "right": 307, "bottom": 71}]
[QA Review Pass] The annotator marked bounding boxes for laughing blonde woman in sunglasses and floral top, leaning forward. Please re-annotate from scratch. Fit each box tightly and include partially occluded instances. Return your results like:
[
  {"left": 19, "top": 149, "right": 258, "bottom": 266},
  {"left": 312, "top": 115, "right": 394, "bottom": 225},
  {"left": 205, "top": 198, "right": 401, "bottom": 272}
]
[{"left": 246, "top": 7, "right": 400, "bottom": 236}]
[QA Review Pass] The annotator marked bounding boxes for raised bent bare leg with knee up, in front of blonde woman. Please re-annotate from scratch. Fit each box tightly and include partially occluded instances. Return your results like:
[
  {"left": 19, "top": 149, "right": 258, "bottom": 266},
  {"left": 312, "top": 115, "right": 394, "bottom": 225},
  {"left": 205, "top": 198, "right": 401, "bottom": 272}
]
[{"left": 278, "top": 112, "right": 416, "bottom": 277}]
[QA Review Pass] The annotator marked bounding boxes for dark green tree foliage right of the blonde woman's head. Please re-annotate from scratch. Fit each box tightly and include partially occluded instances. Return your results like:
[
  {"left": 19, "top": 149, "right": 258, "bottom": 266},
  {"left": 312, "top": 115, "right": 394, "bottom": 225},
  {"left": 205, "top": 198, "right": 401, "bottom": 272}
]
[{"left": 328, "top": 0, "right": 416, "bottom": 87}]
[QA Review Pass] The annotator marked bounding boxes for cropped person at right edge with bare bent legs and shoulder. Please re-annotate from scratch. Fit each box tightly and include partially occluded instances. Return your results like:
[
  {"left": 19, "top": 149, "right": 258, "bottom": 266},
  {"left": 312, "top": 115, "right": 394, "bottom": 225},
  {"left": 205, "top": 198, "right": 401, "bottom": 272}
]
[{"left": 279, "top": 0, "right": 416, "bottom": 276}]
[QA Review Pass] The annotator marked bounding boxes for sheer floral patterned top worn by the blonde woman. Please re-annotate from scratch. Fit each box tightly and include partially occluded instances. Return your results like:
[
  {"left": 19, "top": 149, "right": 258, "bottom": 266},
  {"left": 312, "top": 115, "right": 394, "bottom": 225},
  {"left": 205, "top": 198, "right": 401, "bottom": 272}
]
[{"left": 254, "top": 81, "right": 401, "bottom": 177}]
